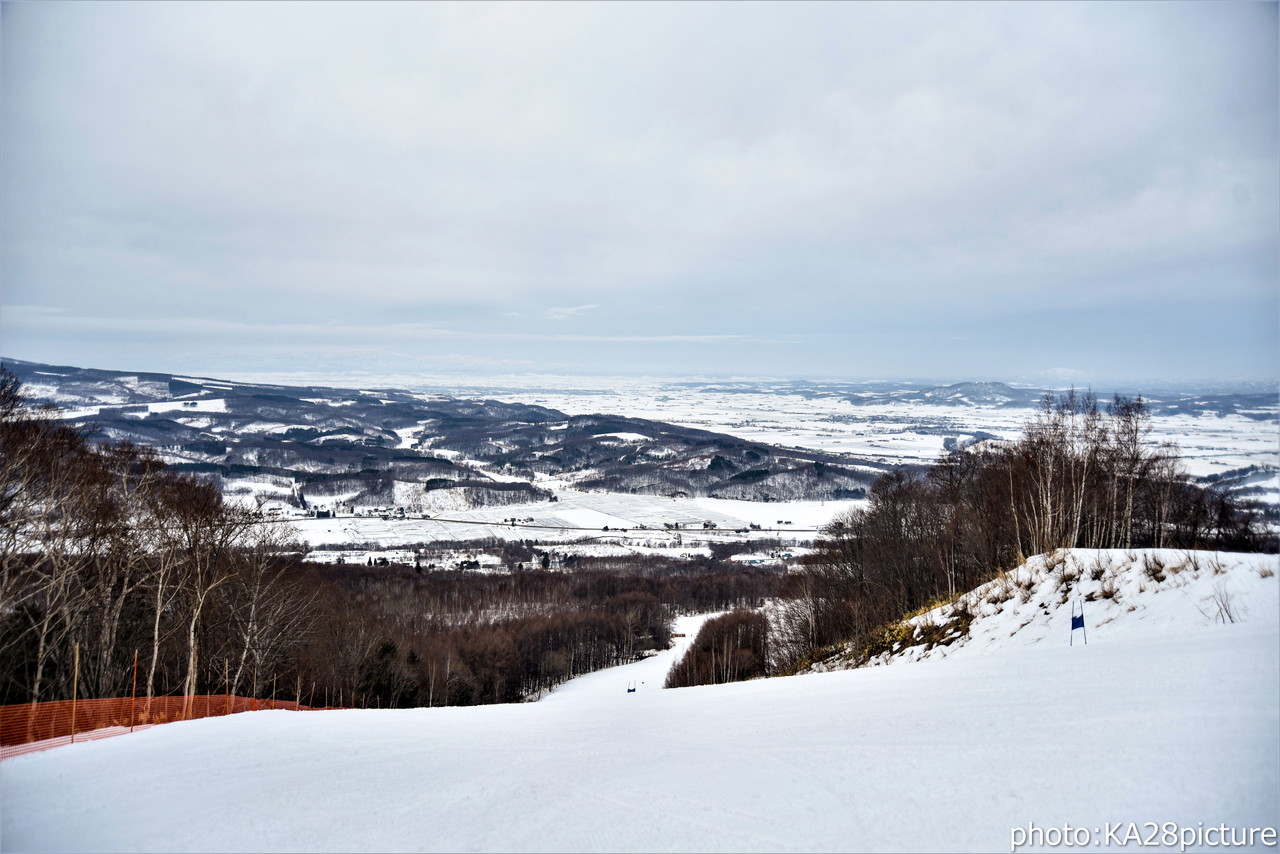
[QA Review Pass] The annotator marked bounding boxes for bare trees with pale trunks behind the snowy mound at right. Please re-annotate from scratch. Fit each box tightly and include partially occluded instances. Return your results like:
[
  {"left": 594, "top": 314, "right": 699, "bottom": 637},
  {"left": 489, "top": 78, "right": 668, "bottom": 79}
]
[{"left": 777, "top": 393, "right": 1272, "bottom": 667}]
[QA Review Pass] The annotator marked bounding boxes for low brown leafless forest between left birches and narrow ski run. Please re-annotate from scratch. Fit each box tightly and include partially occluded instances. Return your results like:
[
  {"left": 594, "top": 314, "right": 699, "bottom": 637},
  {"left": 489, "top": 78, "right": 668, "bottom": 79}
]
[{"left": 302, "top": 558, "right": 782, "bottom": 708}]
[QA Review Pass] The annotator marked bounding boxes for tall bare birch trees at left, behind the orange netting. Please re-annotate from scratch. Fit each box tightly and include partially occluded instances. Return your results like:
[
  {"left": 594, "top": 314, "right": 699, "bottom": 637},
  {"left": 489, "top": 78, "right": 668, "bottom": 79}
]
[{"left": 0, "top": 369, "right": 314, "bottom": 703}]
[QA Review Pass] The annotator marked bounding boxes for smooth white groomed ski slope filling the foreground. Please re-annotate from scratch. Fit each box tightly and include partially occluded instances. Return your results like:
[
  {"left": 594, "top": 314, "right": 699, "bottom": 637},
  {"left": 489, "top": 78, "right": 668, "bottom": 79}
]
[{"left": 0, "top": 552, "right": 1280, "bottom": 851}]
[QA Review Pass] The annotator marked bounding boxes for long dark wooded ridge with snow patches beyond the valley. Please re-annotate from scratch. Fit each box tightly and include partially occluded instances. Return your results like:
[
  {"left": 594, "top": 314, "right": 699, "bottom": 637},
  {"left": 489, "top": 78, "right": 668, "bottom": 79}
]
[{"left": 5, "top": 360, "right": 886, "bottom": 511}]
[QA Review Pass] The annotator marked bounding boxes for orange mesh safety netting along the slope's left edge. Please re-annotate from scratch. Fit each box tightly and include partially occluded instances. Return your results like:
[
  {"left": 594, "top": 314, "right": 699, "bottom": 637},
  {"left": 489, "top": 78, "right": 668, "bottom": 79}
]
[{"left": 0, "top": 694, "right": 337, "bottom": 745}]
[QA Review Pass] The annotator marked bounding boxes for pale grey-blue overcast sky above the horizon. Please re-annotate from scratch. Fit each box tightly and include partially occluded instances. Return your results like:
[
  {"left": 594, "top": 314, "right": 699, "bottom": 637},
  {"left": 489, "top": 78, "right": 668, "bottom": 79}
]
[{"left": 0, "top": 1, "right": 1280, "bottom": 382}]
